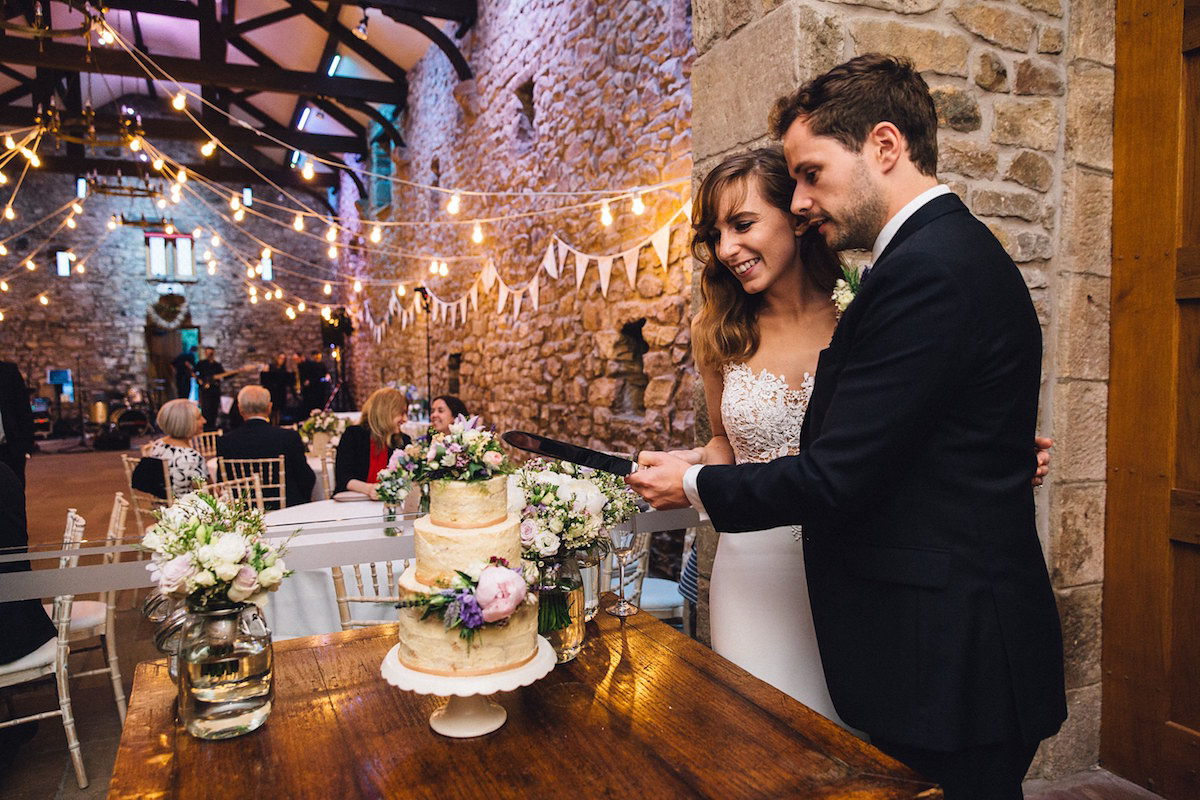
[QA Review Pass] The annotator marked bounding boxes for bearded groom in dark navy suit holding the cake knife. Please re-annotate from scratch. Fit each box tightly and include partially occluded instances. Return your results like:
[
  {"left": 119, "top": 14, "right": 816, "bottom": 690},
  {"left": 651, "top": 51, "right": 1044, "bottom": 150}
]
[{"left": 628, "top": 55, "right": 1067, "bottom": 800}]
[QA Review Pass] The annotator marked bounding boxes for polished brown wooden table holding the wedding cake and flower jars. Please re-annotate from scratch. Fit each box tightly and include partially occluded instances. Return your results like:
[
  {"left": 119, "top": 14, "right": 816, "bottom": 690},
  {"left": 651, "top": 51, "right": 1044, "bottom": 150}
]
[{"left": 108, "top": 604, "right": 942, "bottom": 800}]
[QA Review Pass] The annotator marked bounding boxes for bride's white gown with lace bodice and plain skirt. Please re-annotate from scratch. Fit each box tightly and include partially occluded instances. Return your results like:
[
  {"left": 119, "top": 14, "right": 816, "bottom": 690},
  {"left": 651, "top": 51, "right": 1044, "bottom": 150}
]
[{"left": 709, "top": 363, "right": 846, "bottom": 727}]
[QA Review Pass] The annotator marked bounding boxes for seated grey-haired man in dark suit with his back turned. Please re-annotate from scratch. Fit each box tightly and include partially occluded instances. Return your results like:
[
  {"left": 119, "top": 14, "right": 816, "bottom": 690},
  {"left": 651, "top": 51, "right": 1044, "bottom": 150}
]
[{"left": 217, "top": 386, "right": 317, "bottom": 507}]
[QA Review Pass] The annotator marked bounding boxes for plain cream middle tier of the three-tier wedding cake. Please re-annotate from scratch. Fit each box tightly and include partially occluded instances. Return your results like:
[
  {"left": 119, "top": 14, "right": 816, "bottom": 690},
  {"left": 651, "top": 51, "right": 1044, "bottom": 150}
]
[{"left": 413, "top": 513, "right": 521, "bottom": 587}]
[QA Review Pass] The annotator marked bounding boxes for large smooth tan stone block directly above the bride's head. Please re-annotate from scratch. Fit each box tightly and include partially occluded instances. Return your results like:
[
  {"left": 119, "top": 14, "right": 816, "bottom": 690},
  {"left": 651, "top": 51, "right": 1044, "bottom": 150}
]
[{"left": 691, "top": 5, "right": 842, "bottom": 161}]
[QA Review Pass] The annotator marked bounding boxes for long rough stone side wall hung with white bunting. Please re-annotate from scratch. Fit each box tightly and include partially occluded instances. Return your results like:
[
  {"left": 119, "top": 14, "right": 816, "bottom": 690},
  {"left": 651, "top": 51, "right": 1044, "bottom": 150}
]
[{"left": 342, "top": 0, "right": 694, "bottom": 460}]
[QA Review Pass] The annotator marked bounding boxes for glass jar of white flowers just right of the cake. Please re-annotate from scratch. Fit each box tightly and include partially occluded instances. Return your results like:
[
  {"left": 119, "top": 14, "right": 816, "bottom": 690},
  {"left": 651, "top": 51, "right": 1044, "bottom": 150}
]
[{"left": 517, "top": 458, "right": 636, "bottom": 663}]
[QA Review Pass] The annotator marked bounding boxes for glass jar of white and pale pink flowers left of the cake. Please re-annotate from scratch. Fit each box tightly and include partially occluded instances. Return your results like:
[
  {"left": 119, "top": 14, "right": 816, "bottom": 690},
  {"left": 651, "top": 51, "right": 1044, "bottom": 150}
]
[{"left": 142, "top": 492, "right": 289, "bottom": 739}]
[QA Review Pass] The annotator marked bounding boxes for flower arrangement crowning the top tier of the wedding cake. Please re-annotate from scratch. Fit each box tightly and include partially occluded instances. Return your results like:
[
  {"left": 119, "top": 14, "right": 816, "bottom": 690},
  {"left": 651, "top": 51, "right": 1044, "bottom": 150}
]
[{"left": 402, "top": 415, "right": 512, "bottom": 483}]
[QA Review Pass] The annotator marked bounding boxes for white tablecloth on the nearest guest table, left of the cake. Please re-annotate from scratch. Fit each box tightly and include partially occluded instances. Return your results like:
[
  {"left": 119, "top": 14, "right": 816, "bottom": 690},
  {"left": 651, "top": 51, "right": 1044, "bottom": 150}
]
[{"left": 265, "top": 500, "right": 412, "bottom": 639}]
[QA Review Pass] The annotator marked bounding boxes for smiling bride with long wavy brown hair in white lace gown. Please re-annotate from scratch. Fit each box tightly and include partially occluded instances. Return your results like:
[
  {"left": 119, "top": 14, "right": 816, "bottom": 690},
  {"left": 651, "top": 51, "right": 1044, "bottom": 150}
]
[{"left": 672, "top": 148, "right": 1052, "bottom": 727}]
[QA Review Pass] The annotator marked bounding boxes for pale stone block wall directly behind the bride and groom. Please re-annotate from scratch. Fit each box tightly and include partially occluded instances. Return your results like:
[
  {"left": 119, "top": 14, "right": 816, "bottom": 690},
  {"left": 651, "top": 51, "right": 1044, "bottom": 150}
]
[{"left": 692, "top": 0, "right": 1114, "bottom": 776}]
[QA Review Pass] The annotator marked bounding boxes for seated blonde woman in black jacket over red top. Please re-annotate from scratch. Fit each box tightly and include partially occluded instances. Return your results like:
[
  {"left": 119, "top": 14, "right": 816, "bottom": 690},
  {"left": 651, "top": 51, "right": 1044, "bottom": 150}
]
[{"left": 334, "top": 389, "right": 410, "bottom": 500}]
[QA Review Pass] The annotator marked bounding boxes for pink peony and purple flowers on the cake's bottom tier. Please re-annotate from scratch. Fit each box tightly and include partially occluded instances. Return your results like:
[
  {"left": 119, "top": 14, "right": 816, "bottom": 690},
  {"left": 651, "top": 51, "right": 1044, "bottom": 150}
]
[{"left": 396, "top": 557, "right": 536, "bottom": 649}]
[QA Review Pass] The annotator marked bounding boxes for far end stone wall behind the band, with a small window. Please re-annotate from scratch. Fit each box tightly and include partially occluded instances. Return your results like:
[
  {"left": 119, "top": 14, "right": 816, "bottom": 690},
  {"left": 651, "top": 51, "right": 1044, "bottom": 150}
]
[{"left": 0, "top": 113, "right": 328, "bottom": 416}]
